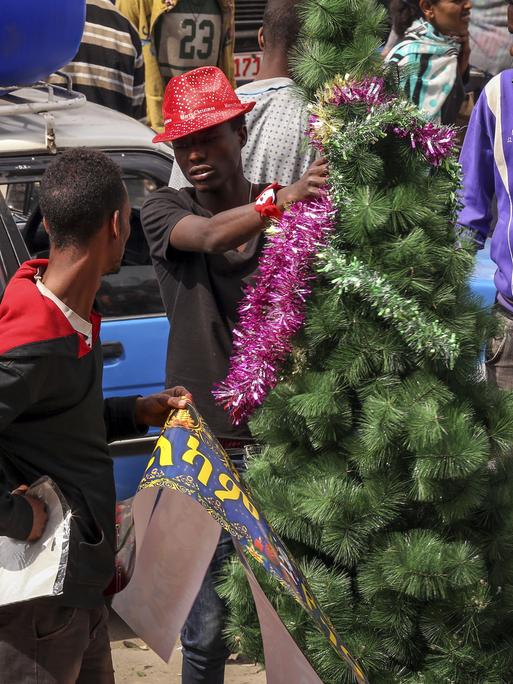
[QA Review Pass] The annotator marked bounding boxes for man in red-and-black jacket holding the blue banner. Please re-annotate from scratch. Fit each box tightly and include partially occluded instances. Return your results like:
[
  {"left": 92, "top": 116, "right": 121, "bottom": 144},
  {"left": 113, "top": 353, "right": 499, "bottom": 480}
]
[{"left": 0, "top": 149, "right": 187, "bottom": 684}]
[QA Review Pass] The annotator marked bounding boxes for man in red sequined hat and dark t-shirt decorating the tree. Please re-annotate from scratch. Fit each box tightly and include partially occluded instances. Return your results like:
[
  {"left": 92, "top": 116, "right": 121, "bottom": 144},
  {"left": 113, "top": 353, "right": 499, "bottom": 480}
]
[{"left": 141, "top": 67, "right": 327, "bottom": 684}]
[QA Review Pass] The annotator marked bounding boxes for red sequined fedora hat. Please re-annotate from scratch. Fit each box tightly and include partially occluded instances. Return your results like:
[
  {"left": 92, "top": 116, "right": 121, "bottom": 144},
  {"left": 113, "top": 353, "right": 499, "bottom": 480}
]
[{"left": 153, "top": 67, "right": 255, "bottom": 142}]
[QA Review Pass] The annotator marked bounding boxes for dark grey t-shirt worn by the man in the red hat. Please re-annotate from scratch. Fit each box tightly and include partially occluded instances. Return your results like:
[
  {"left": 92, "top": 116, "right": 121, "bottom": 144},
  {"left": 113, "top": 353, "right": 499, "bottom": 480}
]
[{"left": 141, "top": 188, "right": 264, "bottom": 439}]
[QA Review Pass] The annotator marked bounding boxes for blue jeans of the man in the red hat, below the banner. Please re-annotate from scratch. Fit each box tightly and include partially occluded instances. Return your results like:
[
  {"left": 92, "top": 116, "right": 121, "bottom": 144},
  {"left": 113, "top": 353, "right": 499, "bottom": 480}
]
[{"left": 181, "top": 456, "right": 243, "bottom": 684}]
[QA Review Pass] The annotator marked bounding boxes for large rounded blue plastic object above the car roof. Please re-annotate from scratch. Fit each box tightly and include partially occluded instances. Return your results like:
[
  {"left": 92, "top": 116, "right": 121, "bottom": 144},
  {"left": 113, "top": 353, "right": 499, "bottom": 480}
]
[{"left": 0, "top": 0, "right": 86, "bottom": 86}]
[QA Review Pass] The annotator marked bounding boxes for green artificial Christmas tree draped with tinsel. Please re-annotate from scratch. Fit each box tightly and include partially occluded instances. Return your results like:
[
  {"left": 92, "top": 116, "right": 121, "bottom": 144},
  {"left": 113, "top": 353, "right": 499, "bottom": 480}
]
[{"left": 217, "top": 0, "right": 513, "bottom": 684}]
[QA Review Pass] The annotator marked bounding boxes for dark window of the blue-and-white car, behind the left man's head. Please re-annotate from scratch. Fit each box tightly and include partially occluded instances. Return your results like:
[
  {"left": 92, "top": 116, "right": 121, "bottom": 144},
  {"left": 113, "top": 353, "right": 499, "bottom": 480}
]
[{"left": 0, "top": 151, "right": 171, "bottom": 318}]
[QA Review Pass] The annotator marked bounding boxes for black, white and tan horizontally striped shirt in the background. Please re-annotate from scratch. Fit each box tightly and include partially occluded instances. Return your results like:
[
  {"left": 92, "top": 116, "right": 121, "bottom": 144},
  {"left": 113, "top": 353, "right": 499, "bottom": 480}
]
[{"left": 51, "top": 0, "right": 145, "bottom": 119}]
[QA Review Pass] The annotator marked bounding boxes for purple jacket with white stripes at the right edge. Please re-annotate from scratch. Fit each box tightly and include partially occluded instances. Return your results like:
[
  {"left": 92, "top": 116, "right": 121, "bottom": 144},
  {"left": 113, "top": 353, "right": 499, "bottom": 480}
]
[{"left": 458, "top": 69, "right": 513, "bottom": 311}]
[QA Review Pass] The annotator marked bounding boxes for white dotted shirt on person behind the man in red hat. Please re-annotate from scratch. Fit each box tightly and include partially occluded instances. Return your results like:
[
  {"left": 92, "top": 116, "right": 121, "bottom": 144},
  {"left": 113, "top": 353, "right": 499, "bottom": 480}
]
[{"left": 169, "top": 78, "right": 316, "bottom": 189}]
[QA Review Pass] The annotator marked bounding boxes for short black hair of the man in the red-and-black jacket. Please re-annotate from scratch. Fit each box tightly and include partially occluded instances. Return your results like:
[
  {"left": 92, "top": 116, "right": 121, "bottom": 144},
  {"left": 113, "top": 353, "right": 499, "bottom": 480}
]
[{"left": 39, "top": 147, "right": 127, "bottom": 249}]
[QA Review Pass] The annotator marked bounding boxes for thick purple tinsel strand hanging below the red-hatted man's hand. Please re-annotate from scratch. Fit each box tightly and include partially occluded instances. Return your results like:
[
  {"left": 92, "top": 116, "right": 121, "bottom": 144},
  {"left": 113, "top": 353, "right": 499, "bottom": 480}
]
[{"left": 213, "top": 195, "right": 335, "bottom": 425}]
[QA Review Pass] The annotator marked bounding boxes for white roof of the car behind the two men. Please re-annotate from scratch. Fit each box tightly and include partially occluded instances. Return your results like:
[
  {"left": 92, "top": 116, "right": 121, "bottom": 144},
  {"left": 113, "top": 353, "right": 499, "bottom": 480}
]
[{"left": 0, "top": 88, "right": 173, "bottom": 157}]
